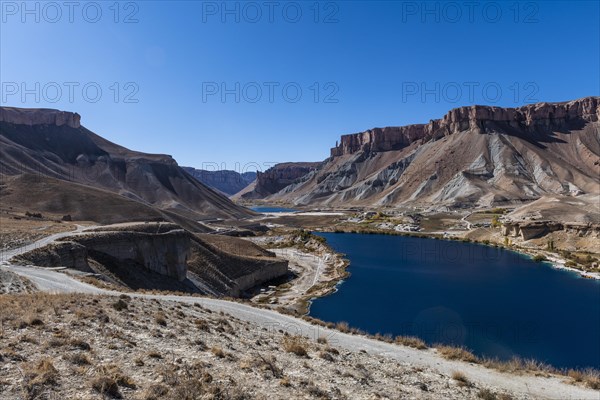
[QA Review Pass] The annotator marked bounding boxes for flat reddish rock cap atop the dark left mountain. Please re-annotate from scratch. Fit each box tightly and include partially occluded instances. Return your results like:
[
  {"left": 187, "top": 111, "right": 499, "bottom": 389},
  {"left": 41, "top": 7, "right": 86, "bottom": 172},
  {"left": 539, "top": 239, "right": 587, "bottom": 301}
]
[{"left": 0, "top": 107, "right": 81, "bottom": 128}]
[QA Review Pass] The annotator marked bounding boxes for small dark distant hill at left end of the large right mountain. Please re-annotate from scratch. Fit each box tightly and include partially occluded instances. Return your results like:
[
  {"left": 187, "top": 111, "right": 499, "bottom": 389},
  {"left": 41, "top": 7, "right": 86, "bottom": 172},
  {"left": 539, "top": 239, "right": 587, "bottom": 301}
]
[{"left": 234, "top": 162, "right": 321, "bottom": 200}]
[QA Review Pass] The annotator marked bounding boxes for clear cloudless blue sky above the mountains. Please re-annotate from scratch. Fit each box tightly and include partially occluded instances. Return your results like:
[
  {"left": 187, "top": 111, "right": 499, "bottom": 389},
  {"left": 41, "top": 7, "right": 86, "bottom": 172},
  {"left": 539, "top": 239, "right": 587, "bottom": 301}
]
[{"left": 0, "top": 0, "right": 600, "bottom": 169}]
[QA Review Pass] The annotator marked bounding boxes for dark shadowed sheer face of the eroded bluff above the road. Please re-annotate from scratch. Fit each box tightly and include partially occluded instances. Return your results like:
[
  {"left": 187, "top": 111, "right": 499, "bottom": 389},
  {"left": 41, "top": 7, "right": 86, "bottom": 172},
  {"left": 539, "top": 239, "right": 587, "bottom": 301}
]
[{"left": 69, "top": 229, "right": 190, "bottom": 282}]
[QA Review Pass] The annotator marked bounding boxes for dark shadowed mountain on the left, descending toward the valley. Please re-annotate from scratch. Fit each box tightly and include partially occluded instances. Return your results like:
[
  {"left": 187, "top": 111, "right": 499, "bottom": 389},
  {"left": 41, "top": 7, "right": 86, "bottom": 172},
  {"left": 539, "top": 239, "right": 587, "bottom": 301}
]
[{"left": 0, "top": 107, "right": 253, "bottom": 222}]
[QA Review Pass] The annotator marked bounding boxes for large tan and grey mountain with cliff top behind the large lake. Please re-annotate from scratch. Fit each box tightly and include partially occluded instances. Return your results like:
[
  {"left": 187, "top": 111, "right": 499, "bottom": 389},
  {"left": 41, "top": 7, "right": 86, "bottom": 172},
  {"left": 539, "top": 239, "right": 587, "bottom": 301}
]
[{"left": 262, "top": 97, "right": 600, "bottom": 207}]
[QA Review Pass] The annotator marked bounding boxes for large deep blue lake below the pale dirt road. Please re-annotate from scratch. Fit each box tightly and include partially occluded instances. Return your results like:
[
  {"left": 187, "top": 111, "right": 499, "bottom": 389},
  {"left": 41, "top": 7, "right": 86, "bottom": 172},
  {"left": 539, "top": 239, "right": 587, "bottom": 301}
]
[{"left": 310, "top": 233, "right": 600, "bottom": 368}]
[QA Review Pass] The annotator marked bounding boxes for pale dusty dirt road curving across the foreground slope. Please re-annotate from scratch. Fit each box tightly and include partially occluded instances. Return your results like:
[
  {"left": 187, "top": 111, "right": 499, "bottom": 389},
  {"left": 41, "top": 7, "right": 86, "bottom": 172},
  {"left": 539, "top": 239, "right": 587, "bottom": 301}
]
[{"left": 0, "top": 232, "right": 600, "bottom": 400}]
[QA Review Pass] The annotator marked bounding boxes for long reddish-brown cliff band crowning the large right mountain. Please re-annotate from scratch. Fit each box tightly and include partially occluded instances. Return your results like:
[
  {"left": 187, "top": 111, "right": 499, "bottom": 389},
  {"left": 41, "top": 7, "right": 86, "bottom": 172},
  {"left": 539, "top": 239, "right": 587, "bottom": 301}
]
[{"left": 331, "top": 97, "right": 600, "bottom": 157}]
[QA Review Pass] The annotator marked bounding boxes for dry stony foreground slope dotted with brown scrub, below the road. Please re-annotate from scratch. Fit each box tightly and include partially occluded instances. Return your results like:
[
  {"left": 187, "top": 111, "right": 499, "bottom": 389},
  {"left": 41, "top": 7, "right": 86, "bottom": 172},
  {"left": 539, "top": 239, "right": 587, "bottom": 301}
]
[{"left": 0, "top": 293, "right": 528, "bottom": 400}]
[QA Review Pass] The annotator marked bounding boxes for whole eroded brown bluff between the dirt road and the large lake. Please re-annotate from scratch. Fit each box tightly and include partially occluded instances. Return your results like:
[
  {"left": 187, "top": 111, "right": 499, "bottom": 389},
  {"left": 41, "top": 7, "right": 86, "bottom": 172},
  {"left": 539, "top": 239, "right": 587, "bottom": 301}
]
[{"left": 15, "top": 223, "right": 288, "bottom": 296}]
